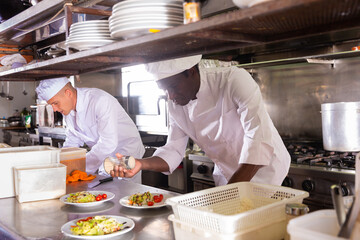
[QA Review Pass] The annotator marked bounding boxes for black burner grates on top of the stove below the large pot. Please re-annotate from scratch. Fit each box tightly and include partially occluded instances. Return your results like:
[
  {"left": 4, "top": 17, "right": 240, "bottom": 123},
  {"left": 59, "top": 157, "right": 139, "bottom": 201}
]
[{"left": 287, "top": 144, "right": 357, "bottom": 170}]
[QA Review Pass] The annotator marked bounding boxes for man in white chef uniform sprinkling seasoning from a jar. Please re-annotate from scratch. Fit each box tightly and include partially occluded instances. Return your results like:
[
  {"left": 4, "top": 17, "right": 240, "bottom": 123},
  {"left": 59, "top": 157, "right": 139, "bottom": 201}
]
[{"left": 111, "top": 56, "right": 290, "bottom": 186}]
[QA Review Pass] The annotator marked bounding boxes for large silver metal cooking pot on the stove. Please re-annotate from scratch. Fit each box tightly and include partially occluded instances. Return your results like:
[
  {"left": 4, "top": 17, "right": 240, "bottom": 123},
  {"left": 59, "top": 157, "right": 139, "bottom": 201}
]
[{"left": 321, "top": 102, "right": 360, "bottom": 152}]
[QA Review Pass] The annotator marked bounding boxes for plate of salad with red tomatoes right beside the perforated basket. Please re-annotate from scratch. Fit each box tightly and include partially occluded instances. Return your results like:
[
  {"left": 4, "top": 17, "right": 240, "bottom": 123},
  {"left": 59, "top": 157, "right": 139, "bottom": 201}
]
[{"left": 119, "top": 192, "right": 167, "bottom": 209}]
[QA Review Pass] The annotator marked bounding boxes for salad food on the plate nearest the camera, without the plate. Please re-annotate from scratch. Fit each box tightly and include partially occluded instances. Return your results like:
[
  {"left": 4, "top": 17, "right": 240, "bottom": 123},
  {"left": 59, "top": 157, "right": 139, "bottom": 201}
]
[{"left": 70, "top": 216, "right": 126, "bottom": 236}]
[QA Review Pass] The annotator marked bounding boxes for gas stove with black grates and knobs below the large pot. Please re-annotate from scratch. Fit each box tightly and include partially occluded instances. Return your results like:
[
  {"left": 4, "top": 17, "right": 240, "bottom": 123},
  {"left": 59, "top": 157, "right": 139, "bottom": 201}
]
[{"left": 282, "top": 143, "right": 357, "bottom": 210}]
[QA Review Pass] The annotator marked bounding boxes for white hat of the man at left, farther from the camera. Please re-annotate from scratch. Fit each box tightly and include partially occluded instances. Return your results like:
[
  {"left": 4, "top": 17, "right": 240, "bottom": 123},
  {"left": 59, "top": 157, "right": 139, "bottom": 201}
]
[{"left": 35, "top": 77, "right": 70, "bottom": 101}]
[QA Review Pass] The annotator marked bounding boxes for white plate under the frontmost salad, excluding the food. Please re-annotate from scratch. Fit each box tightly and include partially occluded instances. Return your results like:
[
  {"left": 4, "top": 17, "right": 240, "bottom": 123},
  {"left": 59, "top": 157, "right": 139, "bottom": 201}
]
[{"left": 61, "top": 215, "right": 135, "bottom": 240}]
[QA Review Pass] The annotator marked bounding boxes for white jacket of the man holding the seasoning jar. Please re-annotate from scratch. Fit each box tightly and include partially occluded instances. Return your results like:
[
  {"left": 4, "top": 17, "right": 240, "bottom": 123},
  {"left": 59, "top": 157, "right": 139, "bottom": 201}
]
[{"left": 154, "top": 67, "right": 290, "bottom": 186}]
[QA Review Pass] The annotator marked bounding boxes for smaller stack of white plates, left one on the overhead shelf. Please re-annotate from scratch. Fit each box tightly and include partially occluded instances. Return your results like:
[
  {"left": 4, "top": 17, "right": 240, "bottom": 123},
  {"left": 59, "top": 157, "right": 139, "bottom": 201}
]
[{"left": 65, "top": 20, "right": 115, "bottom": 50}]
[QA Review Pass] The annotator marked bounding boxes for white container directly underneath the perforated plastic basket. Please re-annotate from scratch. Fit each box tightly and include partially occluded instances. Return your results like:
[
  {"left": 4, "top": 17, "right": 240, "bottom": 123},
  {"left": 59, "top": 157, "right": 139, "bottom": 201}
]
[{"left": 168, "top": 214, "right": 286, "bottom": 240}]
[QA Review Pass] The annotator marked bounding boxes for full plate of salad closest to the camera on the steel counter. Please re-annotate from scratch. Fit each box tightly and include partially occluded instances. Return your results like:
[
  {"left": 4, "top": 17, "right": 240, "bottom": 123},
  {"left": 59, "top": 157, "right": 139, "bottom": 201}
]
[{"left": 61, "top": 215, "right": 135, "bottom": 239}]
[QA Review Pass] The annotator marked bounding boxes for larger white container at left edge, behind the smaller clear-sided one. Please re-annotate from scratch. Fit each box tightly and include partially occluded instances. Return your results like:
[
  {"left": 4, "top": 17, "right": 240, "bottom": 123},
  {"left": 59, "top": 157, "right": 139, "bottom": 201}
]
[{"left": 0, "top": 146, "right": 60, "bottom": 198}]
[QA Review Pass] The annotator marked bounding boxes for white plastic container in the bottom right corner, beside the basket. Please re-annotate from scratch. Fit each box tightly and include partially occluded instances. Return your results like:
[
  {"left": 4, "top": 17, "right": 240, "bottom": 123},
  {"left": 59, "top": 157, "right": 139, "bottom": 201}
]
[{"left": 287, "top": 209, "right": 346, "bottom": 240}]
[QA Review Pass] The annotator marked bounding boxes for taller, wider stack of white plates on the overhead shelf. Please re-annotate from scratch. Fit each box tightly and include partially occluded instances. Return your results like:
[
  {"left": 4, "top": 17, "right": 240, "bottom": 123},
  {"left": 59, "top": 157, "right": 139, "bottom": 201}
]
[{"left": 109, "top": 0, "right": 184, "bottom": 39}]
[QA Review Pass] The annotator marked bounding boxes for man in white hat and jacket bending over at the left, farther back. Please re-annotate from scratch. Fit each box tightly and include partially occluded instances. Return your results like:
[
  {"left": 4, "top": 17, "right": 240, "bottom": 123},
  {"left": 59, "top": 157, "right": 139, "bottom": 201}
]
[{"left": 36, "top": 77, "right": 145, "bottom": 183}]
